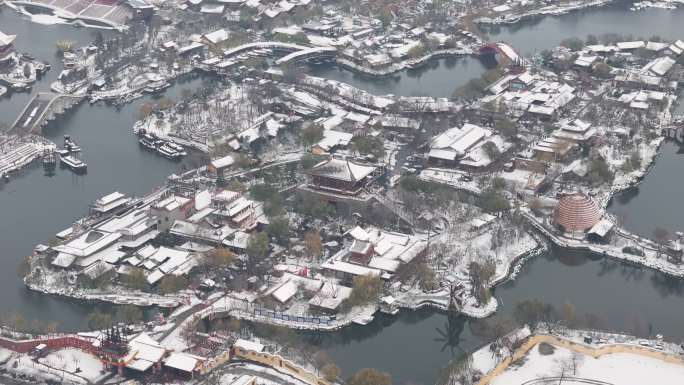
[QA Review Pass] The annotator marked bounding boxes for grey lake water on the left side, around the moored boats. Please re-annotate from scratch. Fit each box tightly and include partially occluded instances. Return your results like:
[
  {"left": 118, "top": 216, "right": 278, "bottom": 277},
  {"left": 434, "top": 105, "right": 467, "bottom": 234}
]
[{"left": 0, "top": 7, "right": 203, "bottom": 330}]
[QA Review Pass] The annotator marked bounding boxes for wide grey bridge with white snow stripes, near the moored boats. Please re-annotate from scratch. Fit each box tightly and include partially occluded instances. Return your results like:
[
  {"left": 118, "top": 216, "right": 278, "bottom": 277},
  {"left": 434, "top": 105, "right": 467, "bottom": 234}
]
[{"left": 10, "top": 92, "right": 83, "bottom": 135}]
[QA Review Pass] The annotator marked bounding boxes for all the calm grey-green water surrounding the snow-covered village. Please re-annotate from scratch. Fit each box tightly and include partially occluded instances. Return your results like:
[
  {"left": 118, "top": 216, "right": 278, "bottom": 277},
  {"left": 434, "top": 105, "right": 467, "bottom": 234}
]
[{"left": 0, "top": 4, "right": 684, "bottom": 384}]
